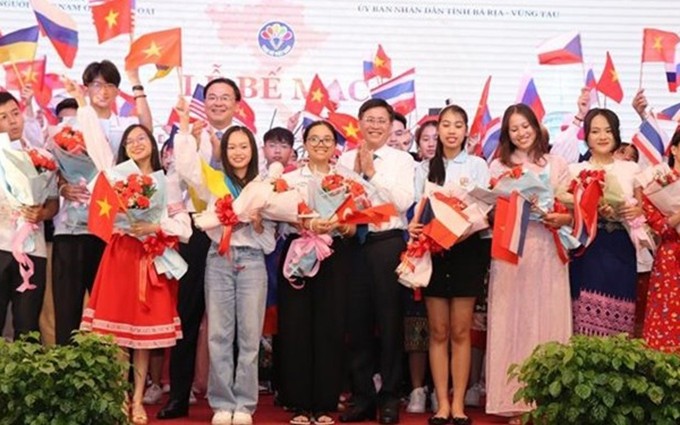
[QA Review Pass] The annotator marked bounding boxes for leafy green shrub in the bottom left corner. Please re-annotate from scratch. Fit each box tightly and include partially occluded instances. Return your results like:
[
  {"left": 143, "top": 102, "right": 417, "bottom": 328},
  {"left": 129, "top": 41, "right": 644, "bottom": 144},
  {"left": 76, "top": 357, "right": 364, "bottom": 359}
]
[{"left": 0, "top": 333, "right": 128, "bottom": 425}]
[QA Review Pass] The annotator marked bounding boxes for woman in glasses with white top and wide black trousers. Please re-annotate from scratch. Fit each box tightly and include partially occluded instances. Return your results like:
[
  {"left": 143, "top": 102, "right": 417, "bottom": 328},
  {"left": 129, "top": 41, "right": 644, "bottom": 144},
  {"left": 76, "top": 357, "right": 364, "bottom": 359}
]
[{"left": 278, "top": 121, "right": 356, "bottom": 425}]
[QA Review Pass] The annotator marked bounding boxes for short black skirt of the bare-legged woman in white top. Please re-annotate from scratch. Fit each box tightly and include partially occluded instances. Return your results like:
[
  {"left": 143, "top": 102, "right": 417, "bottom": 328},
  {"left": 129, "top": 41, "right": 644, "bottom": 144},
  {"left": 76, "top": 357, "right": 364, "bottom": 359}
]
[{"left": 423, "top": 233, "right": 491, "bottom": 298}]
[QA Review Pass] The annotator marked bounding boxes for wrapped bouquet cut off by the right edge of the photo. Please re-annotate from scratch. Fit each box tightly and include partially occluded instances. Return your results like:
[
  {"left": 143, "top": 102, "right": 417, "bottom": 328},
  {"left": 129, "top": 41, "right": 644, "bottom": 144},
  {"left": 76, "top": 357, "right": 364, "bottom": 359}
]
[{"left": 636, "top": 164, "right": 680, "bottom": 233}]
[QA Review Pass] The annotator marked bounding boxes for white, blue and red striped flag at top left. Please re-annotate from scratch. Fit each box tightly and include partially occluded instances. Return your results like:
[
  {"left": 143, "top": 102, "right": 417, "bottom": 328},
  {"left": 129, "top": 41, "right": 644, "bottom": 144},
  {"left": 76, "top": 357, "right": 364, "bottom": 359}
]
[{"left": 31, "top": 0, "right": 78, "bottom": 68}]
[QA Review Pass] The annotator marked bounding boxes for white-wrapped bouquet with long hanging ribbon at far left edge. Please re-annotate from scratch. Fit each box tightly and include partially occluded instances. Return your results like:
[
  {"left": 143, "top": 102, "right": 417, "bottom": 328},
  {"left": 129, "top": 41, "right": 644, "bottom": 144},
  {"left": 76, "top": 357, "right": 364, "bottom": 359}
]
[{"left": 0, "top": 133, "right": 57, "bottom": 292}]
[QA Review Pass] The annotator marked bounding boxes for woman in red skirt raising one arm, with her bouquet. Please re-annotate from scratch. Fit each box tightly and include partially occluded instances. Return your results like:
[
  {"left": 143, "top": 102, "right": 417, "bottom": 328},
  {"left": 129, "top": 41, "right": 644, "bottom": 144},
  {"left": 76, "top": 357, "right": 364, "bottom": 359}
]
[{"left": 65, "top": 80, "right": 191, "bottom": 424}]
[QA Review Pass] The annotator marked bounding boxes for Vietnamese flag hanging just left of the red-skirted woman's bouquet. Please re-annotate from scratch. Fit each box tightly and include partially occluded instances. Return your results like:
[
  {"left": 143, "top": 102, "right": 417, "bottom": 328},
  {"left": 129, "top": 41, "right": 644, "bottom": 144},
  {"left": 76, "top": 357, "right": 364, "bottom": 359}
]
[{"left": 87, "top": 173, "right": 121, "bottom": 242}]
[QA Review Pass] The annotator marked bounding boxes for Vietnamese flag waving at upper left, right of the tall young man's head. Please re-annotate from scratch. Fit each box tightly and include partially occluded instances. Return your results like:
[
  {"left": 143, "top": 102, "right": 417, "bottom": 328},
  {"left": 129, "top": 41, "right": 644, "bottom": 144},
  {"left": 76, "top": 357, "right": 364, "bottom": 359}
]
[{"left": 125, "top": 28, "right": 182, "bottom": 70}]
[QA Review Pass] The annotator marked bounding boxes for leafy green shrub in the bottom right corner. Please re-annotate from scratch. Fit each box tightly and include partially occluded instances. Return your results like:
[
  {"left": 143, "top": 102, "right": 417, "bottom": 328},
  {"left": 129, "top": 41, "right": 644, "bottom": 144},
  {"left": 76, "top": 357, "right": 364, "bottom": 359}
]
[{"left": 509, "top": 335, "right": 680, "bottom": 425}]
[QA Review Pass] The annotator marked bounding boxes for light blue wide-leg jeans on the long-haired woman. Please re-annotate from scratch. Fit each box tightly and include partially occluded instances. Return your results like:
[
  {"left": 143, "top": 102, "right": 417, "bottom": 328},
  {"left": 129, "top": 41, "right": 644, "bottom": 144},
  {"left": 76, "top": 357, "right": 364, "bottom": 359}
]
[{"left": 205, "top": 242, "right": 267, "bottom": 414}]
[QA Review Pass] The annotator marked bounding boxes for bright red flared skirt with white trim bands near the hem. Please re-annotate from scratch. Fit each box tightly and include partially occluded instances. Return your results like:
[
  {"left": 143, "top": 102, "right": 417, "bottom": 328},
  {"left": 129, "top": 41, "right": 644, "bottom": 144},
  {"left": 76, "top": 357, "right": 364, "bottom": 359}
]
[{"left": 80, "top": 235, "right": 182, "bottom": 349}]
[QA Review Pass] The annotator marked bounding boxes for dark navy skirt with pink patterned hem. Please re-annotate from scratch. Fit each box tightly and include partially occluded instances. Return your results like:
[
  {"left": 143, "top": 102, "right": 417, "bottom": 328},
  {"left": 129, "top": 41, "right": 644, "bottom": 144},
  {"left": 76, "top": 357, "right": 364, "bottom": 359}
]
[{"left": 569, "top": 222, "right": 637, "bottom": 335}]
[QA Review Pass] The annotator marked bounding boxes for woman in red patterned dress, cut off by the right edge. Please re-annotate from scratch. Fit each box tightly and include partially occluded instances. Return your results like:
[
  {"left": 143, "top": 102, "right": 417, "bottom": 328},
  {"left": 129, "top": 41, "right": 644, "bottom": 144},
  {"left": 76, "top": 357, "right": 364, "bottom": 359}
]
[{"left": 641, "top": 130, "right": 680, "bottom": 353}]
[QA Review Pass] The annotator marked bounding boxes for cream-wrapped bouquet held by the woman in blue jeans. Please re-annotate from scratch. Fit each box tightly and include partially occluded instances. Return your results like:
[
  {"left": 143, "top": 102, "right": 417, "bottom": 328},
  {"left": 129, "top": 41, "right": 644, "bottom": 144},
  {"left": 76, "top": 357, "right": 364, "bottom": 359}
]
[{"left": 232, "top": 162, "right": 302, "bottom": 223}]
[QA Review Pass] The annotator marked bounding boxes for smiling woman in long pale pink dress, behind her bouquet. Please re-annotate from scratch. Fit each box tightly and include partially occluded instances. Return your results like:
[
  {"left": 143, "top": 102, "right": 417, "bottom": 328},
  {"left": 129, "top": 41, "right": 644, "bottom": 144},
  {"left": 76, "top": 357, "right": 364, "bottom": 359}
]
[{"left": 486, "top": 104, "right": 572, "bottom": 424}]
